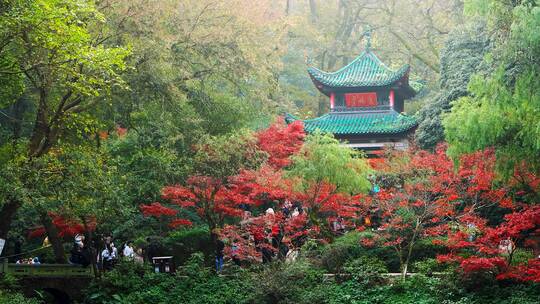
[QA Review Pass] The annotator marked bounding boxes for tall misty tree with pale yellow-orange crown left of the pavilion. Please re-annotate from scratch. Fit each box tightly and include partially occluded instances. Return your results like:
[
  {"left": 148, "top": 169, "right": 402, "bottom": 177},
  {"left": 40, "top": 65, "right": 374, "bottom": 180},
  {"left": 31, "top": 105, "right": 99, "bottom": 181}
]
[{"left": 97, "top": 0, "right": 280, "bottom": 135}]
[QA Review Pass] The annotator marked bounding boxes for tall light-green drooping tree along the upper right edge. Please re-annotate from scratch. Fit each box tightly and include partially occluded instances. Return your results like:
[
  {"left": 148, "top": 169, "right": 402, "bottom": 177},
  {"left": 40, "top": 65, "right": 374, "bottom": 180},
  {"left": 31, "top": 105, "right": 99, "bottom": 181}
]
[{"left": 444, "top": 0, "right": 540, "bottom": 172}]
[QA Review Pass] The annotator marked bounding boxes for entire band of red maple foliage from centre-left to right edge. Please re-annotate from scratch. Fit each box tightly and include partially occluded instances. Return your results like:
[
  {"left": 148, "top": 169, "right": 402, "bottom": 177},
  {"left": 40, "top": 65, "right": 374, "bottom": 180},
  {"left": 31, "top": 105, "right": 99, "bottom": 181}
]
[{"left": 141, "top": 117, "right": 540, "bottom": 281}]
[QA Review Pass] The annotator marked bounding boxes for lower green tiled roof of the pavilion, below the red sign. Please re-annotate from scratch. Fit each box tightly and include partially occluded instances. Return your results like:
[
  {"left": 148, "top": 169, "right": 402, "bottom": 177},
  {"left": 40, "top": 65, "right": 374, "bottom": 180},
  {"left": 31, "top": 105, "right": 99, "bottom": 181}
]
[{"left": 285, "top": 110, "right": 417, "bottom": 135}]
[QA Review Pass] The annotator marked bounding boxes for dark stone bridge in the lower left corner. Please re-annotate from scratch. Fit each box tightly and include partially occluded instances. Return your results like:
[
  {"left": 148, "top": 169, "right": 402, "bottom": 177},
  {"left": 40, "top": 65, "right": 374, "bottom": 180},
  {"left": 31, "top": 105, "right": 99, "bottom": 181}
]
[{"left": 0, "top": 259, "right": 94, "bottom": 304}]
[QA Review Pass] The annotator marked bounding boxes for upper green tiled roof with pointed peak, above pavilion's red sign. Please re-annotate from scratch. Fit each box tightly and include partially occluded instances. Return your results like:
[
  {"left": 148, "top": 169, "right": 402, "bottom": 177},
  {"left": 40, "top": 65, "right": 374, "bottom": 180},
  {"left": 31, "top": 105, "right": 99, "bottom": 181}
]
[{"left": 308, "top": 50, "right": 409, "bottom": 87}]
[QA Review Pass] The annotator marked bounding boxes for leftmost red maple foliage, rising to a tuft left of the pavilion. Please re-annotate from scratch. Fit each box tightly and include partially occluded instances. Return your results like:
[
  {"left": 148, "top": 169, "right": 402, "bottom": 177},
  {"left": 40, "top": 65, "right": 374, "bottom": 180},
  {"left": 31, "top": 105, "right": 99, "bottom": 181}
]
[{"left": 141, "top": 119, "right": 305, "bottom": 230}]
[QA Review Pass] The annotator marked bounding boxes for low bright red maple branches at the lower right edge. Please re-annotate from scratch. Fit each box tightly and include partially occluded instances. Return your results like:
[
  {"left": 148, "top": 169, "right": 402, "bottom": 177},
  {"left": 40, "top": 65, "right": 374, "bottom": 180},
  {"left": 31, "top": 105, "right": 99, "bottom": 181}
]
[{"left": 438, "top": 205, "right": 540, "bottom": 282}]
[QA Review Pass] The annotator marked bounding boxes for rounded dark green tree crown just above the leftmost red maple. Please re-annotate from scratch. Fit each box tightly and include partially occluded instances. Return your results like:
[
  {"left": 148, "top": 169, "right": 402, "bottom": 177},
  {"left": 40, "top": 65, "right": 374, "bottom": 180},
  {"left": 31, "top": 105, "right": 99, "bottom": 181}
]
[{"left": 102, "top": 116, "right": 193, "bottom": 206}]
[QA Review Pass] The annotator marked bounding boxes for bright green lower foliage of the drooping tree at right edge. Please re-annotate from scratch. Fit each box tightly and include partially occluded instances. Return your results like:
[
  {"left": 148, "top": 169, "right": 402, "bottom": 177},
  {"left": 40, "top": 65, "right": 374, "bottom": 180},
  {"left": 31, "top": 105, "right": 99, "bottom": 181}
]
[{"left": 444, "top": 69, "right": 540, "bottom": 172}]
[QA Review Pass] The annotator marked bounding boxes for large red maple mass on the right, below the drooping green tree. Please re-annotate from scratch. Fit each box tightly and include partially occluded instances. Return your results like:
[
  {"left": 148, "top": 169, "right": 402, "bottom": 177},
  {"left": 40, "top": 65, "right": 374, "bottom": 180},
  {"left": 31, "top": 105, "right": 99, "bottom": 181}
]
[{"left": 359, "top": 145, "right": 540, "bottom": 280}]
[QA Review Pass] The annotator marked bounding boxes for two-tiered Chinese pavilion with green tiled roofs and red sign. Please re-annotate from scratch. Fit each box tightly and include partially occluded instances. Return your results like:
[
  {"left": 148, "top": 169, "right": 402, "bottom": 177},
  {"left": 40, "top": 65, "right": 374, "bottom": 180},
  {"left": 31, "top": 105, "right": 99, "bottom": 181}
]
[{"left": 286, "top": 42, "right": 417, "bottom": 155}]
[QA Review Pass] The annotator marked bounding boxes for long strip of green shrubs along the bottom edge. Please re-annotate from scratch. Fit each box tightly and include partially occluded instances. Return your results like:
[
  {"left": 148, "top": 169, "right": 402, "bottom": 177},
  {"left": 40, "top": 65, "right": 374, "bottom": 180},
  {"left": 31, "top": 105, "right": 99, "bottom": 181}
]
[{"left": 86, "top": 256, "right": 540, "bottom": 304}]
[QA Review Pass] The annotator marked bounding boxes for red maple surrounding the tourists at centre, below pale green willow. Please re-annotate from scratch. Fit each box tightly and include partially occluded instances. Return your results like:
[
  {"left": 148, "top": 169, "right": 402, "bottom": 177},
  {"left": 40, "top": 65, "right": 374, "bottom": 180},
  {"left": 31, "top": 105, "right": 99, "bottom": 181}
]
[{"left": 218, "top": 171, "right": 360, "bottom": 261}]
